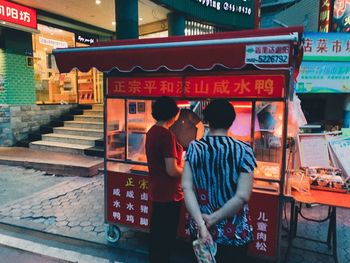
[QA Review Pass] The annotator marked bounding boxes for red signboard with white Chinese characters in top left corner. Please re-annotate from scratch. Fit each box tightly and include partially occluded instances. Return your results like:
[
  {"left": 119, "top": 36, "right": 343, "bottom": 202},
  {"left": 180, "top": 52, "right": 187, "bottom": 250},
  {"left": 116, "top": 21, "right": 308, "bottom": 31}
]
[{"left": 0, "top": 0, "right": 37, "bottom": 29}]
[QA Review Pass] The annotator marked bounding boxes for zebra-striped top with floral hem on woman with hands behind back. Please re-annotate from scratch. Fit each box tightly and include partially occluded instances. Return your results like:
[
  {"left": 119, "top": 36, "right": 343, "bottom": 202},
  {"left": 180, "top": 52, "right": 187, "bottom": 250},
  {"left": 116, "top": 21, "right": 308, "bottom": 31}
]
[{"left": 185, "top": 136, "right": 256, "bottom": 246}]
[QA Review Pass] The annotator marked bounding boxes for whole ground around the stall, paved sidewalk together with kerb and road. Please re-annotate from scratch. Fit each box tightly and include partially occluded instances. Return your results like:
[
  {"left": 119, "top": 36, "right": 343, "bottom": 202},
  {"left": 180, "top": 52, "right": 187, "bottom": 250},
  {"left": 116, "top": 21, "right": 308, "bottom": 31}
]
[{"left": 0, "top": 165, "right": 350, "bottom": 263}]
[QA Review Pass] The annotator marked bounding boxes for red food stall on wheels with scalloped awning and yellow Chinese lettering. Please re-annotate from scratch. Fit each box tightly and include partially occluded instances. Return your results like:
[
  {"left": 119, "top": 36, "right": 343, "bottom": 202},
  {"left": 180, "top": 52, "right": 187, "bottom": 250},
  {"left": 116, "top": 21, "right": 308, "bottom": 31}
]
[{"left": 54, "top": 27, "right": 302, "bottom": 260}]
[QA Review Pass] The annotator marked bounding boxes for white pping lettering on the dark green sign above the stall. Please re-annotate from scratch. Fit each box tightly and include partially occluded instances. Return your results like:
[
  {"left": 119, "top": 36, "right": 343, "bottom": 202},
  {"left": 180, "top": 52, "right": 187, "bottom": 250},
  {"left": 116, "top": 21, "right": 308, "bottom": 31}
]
[{"left": 194, "top": 0, "right": 252, "bottom": 15}]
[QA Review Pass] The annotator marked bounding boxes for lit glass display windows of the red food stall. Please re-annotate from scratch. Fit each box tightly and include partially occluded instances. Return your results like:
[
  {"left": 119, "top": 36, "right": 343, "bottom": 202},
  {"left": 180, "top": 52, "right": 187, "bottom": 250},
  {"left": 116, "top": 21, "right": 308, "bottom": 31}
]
[{"left": 106, "top": 98, "right": 283, "bottom": 193}]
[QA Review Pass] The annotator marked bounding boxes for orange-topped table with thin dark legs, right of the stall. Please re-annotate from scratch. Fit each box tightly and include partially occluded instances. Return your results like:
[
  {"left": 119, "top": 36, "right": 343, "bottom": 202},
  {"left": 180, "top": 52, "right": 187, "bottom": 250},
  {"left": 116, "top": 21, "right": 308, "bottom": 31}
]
[{"left": 286, "top": 190, "right": 350, "bottom": 263}]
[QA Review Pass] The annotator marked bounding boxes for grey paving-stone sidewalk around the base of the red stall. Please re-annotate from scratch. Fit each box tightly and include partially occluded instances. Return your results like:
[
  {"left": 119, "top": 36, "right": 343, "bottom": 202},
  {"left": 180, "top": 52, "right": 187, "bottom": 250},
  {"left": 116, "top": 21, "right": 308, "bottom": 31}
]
[{"left": 0, "top": 166, "right": 350, "bottom": 263}]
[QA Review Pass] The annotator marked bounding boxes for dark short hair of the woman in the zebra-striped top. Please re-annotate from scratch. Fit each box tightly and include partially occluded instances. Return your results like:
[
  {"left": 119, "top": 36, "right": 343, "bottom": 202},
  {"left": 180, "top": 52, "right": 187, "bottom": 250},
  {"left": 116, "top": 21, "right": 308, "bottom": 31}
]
[{"left": 203, "top": 99, "right": 236, "bottom": 129}]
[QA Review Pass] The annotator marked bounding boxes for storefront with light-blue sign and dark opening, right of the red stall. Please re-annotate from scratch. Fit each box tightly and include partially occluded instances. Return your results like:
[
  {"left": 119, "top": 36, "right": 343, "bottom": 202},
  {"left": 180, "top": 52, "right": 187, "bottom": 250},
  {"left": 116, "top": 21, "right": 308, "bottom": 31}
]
[{"left": 295, "top": 33, "right": 350, "bottom": 131}]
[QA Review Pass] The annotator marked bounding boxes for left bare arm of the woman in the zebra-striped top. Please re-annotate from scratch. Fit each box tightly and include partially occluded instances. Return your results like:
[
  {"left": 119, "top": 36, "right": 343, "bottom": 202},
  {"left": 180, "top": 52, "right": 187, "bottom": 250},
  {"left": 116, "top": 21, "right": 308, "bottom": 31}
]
[{"left": 181, "top": 161, "right": 212, "bottom": 241}]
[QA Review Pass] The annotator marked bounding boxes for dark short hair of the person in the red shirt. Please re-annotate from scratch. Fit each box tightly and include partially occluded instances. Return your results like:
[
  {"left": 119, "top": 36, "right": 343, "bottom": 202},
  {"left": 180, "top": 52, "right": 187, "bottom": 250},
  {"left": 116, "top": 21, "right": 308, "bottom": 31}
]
[{"left": 152, "top": 96, "right": 179, "bottom": 121}]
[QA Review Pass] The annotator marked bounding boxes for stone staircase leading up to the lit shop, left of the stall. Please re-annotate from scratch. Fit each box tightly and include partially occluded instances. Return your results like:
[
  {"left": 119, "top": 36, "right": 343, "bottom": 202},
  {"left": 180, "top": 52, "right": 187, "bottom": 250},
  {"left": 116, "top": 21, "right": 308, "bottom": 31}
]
[{"left": 29, "top": 104, "right": 103, "bottom": 156}]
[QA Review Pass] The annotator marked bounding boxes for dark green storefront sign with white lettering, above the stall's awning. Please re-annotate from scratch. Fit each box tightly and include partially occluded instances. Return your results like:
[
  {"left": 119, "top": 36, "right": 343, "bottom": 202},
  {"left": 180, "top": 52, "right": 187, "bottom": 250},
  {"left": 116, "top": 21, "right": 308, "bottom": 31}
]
[{"left": 154, "top": 0, "right": 259, "bottom": 29}]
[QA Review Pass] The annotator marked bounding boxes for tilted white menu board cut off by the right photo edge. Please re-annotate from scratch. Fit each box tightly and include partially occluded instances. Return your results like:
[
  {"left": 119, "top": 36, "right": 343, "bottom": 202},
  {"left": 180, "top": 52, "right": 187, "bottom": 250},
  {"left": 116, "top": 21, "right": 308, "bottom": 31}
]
[{"left": 329, "top": 137, "right": 350, "bottom": 177}]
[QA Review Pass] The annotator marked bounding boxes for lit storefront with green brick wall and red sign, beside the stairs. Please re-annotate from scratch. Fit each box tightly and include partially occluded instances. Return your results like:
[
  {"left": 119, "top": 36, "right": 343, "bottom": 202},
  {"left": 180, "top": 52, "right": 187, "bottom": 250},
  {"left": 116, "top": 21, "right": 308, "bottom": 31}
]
[{"left": 0, "top": 0, "right": 113, "bottom": 146}]
